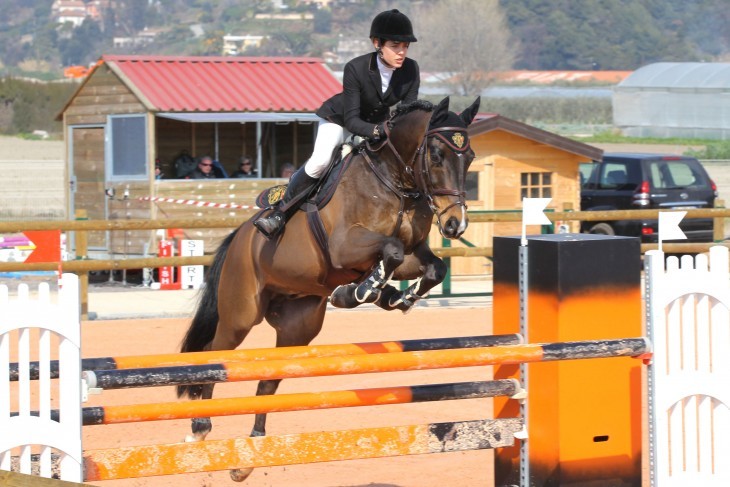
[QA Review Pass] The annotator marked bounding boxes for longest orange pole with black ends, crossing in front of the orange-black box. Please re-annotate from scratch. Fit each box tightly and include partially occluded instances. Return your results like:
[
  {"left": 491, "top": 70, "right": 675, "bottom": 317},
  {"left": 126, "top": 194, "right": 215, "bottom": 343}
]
[{"left": 84, "top": 337, "right": 650, "bottom": 390}]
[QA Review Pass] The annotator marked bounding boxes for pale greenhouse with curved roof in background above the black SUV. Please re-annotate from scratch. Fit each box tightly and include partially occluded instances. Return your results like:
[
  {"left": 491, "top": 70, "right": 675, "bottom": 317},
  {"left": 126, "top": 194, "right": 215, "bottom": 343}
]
[{"left": 613, "top": 63, "right": 730, "bottom": 140}]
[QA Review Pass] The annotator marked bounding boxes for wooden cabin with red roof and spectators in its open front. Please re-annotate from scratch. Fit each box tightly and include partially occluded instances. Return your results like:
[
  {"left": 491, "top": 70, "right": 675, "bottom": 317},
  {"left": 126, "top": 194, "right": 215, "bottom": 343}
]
[{"left": 58, "top": 56, "right": 342, "bottom": 255}]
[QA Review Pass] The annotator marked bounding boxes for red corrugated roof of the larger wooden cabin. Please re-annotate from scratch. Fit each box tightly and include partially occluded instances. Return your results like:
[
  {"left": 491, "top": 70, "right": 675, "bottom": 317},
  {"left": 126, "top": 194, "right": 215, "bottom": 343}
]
[{"left": 102, "top": 56, "right": 342, "bottom": 112}]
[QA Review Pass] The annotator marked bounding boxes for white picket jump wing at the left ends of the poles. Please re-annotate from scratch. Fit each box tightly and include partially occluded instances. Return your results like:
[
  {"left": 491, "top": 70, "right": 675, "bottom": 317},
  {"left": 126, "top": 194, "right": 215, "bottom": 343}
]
[{"left": 0, "top": 274, "right": 83, "bottom": 482}]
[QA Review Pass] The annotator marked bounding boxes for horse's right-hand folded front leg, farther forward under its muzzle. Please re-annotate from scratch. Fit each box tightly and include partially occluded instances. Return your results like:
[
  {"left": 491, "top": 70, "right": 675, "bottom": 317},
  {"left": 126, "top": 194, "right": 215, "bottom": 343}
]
[{"left": 375, "top": 242, "right": 448, "bottom": 313}]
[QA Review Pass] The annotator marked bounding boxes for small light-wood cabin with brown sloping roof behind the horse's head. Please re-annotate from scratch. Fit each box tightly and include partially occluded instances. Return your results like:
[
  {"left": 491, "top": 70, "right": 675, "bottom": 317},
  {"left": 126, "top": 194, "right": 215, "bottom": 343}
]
[{"left": 438, "top": 115, "right": 603, "bottom": 275}]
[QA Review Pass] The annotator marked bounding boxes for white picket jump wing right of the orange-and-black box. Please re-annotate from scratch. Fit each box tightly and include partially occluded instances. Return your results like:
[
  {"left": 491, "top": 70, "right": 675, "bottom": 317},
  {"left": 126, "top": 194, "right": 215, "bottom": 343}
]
[{"left": 645, "top": 246, "right": 730, "bottom": 487}]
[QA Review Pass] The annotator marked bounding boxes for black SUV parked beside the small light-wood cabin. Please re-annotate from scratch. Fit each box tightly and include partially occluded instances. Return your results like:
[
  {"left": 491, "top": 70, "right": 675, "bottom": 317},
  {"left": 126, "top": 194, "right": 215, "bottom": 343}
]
[{"left": 580, "top": 153, "right": 717, "bottom": 243}]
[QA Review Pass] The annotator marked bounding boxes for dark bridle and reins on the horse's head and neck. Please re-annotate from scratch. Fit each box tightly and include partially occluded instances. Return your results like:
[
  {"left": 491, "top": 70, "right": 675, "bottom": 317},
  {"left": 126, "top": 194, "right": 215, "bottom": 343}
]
[{"left": 362, "top": 123, "right": 470, "bottom": 235}]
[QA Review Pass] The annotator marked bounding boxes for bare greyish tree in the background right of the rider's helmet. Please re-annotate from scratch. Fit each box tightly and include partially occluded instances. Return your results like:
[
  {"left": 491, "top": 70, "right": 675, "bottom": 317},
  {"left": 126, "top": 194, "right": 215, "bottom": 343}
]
[{"left": 414, "top": 0, "right": 517, "bottom": 96}]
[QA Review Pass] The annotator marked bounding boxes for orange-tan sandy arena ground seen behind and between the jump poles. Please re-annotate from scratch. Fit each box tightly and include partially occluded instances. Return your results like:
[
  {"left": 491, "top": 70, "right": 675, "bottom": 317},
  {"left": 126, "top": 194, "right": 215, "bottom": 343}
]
[{"left": 82, "top": 307, "right": 500, "bottom": 487}]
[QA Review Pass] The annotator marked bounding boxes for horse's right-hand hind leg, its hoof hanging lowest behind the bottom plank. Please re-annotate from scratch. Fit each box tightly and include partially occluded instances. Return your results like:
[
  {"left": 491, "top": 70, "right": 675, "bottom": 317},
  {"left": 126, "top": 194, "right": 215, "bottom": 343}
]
[{"left": 231, "top": 296, "right": 327, "bottom": 482}]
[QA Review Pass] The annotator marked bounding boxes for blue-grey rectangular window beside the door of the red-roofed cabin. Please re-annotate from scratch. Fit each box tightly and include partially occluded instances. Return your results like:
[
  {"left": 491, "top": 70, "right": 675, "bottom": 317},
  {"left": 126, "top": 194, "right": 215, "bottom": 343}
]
[{"left": 107, "top": 115, "right": 148, "bottom": 179}]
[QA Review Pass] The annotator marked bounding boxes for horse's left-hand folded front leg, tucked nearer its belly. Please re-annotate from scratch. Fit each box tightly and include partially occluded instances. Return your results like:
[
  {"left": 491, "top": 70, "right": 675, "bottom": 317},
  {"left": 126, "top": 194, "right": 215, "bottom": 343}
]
[{"left": 330, "top": 234, "right": 405, "bottom": 308}]
